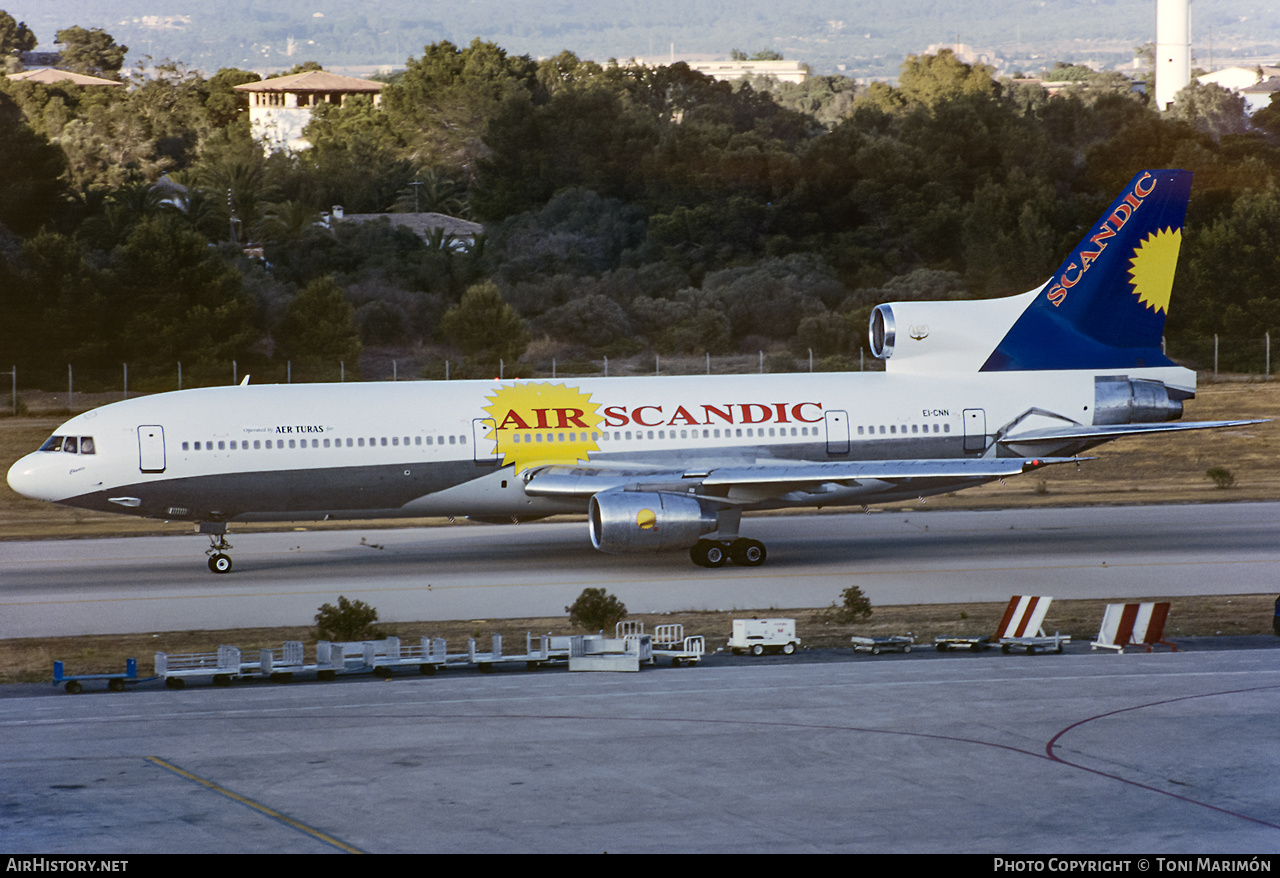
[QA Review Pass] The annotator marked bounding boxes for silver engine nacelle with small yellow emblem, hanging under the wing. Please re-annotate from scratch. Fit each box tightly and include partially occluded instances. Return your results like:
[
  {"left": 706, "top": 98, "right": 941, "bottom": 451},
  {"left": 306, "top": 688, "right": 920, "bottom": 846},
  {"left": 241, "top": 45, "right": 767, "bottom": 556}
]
[{"left": 588, "top": 490, "right": 719, "bottom": 554}]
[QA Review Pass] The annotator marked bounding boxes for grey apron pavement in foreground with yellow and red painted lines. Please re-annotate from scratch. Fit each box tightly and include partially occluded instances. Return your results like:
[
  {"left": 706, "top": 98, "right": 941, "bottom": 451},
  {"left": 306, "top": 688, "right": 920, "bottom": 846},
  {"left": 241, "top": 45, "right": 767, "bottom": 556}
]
[{"left": 0, "top": 649, "right": 1280, "bottom": 854}]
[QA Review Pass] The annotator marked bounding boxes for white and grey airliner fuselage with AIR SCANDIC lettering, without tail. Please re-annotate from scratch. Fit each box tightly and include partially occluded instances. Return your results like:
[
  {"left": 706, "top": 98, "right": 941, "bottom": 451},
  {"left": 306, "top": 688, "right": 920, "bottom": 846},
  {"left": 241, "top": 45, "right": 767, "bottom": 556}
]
[{"left": 9, "top": 370, "right": 1183, "bottom": 521}]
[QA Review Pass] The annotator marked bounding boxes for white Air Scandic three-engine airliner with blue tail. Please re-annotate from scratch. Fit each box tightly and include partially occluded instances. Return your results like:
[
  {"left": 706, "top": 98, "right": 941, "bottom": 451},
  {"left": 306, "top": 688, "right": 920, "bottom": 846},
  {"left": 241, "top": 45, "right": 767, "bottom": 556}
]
[{"left": 9, "top": 170, "right": 1253, "bottom": 573}]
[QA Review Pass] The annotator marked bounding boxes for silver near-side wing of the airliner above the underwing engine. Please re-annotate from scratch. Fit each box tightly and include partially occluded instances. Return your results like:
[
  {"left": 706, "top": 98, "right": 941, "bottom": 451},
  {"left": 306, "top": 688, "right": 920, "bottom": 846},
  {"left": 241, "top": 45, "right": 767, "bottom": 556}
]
[{"left": 525, "top": 457, "right": 1079, "bottom": 498}]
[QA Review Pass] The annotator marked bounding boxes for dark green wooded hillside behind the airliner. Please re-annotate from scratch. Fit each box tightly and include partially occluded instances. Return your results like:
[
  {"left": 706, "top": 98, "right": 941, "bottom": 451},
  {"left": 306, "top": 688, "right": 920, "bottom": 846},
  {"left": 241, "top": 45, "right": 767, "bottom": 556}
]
[{"left": 0, "top": 22, "right": 1280, "bottom": 390}]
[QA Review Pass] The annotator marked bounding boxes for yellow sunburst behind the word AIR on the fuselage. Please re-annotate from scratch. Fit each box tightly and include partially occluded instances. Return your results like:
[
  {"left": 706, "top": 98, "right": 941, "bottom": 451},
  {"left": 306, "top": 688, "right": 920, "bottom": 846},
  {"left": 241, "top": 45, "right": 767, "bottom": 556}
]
[{"left": 485, "top": 381, "right": 603, "bottom": 472}]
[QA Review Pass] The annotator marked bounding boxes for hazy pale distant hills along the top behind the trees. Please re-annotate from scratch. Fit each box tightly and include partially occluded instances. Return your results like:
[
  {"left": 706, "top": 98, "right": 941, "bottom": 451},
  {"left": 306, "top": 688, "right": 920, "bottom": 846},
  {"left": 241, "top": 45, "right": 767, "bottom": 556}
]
[{"left": 10, "top": 0, "right": 1280, "bottom": 77}]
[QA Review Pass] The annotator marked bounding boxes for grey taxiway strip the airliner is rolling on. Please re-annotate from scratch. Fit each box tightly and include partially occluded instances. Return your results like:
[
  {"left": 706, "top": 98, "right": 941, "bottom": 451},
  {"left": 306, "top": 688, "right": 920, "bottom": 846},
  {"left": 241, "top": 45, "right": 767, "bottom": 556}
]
[{"left": 0, "top": 503, "right": 1280, "bottom": 639}]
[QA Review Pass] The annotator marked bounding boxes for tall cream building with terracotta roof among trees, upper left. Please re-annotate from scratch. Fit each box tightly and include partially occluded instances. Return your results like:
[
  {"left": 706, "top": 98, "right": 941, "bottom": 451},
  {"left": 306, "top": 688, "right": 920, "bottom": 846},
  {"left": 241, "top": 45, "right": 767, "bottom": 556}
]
[{"left": 236, "top": 70, "right": 383, "bottom": 152}]
